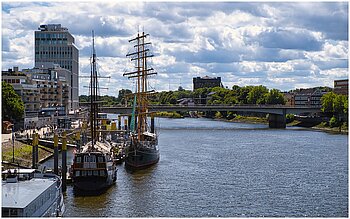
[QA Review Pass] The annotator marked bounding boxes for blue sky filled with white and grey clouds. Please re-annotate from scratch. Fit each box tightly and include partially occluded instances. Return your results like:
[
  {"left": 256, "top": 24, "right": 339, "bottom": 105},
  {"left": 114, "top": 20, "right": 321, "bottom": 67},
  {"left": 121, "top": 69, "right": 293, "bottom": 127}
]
[{"left": 2, "top": 1, "right": 349, "bottom": 96}]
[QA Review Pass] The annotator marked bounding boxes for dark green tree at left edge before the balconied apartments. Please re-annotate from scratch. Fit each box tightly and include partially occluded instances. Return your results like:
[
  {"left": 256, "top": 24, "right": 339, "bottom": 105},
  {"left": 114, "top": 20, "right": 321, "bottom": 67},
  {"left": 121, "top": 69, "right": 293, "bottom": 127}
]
[{"left": 1, "top": 81, "right": 24, "bottom": 122}]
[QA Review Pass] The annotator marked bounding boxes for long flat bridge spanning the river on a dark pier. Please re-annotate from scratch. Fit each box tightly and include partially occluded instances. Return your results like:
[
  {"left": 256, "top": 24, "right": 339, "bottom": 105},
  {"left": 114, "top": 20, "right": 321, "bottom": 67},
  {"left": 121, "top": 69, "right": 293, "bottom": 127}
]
[{"left": 100, "top": 104, "right": 321, "bottom": 128}]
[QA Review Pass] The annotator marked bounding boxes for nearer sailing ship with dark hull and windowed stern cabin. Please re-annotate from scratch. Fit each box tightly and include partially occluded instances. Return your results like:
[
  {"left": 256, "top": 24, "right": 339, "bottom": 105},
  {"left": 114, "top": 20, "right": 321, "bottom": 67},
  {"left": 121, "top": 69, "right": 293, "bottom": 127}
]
[{"left": 71, "top": 32, "right": 117, "bottom": 191}]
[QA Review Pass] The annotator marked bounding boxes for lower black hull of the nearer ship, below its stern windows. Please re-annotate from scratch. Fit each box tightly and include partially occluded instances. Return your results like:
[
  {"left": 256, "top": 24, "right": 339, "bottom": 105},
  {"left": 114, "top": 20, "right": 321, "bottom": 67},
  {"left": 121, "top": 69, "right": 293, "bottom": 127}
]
[{"left": 73, "top": 176, "right": 116, "bottom": 192}]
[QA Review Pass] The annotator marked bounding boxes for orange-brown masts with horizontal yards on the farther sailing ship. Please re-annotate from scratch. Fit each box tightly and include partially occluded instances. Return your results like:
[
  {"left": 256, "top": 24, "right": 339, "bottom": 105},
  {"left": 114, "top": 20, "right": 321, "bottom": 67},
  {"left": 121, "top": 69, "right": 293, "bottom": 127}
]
[{"left": 123, "top": 32, "right": 157, "bottom": 141}]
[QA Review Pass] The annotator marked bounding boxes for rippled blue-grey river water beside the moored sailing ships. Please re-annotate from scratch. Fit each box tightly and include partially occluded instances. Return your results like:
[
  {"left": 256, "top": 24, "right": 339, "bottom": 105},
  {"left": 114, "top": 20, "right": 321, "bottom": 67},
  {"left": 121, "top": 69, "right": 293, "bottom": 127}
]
[{"left": 42, "top": 118, "right": 348, "bottom": 217}]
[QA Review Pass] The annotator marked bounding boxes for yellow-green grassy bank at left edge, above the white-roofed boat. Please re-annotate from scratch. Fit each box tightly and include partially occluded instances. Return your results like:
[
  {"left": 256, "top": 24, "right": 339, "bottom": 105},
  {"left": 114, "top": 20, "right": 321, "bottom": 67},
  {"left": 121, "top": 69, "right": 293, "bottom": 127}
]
[{"left": 1, "top": 141, "right": 53, "bottom": 169}]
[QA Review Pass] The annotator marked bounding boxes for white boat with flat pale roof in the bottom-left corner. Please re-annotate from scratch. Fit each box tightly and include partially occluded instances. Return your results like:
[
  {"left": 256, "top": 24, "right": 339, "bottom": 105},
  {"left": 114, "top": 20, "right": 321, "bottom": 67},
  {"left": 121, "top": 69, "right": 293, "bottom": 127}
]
[{"left": 1, "top": 169, "right": 65, "bottom": 217}]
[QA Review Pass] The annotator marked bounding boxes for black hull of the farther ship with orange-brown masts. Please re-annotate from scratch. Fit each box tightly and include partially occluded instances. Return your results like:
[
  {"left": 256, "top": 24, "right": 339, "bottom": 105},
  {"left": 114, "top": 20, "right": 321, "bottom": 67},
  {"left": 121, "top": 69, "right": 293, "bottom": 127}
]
[{"left": 125, "top": 149, "right": 160, "bottom": 170}]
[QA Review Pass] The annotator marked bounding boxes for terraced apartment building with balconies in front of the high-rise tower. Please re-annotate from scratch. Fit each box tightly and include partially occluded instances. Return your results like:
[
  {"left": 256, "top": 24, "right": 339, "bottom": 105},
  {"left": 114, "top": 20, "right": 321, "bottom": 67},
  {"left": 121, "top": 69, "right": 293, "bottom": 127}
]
[{"left": 2, "top": 66, "right": 70, "bottom": 128}]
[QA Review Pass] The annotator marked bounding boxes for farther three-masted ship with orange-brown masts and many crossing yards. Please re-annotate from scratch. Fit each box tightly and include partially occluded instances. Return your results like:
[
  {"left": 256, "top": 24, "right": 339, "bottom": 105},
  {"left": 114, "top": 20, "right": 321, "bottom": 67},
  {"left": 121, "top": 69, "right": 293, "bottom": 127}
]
[{"left": 123, "top": 32, "right": 160, "bottom": 170}]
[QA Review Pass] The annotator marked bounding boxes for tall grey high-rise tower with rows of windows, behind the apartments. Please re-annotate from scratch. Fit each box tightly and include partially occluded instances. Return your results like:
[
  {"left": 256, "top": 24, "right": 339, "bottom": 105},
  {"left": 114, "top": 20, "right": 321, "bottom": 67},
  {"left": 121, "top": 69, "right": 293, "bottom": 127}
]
[{"left": 35, "top": 24, "right": 79, "bottom": 111}]
